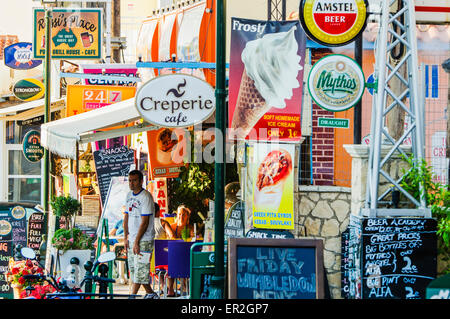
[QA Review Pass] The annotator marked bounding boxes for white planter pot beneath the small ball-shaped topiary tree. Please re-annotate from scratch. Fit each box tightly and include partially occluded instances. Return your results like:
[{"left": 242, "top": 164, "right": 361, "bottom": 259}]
[{"left": 52, "top": 248, "right": 92, "bottom": 291}]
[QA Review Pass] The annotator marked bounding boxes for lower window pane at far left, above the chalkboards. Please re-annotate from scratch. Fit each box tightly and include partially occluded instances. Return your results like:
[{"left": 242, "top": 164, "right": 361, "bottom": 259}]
[{"left": 8, "top": 178, "right": 41, "bottom": 203}]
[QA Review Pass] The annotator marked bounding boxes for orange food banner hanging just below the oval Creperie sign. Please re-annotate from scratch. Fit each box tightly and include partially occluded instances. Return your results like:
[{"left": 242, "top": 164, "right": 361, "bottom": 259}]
[{"left": 147, "top": 128, "right": 187, "bottom": 179}]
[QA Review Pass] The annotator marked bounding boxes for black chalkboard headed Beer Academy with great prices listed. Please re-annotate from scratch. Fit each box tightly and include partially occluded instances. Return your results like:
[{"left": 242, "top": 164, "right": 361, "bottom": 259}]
[{"left": 361, "top": 218, "right": 437, "bottom": 299}]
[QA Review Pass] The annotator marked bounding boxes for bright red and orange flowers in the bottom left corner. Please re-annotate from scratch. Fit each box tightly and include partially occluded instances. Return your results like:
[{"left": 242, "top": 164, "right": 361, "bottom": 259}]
[{"left": 5, "top": 258, "right": 44, "bottom": 299}]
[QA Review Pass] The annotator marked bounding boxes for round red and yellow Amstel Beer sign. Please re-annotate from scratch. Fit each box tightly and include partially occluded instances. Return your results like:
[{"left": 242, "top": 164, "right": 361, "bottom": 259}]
[{"left": 299, "top": 0, "right": 368, "bottom": 46}]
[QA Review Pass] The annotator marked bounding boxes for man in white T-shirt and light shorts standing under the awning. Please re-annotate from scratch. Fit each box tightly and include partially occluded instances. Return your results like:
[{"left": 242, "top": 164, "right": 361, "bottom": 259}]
[{"left": 123, "top": 170, "right": 159, "bottom": 299}]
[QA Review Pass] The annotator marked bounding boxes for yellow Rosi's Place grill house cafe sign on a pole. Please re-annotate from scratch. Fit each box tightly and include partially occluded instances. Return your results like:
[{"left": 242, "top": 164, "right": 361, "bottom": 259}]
[{"left": 33, "top": 8, "right": 102, "bottom": 59}]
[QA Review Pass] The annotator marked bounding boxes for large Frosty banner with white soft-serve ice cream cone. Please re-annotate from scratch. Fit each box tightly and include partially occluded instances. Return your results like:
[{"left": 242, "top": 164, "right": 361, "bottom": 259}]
[{"left": 228, "top": 18, "right": 306, "bottom": 142}]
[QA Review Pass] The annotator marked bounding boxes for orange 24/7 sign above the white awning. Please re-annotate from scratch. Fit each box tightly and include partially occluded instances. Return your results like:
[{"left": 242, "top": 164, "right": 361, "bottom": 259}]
[{"left": 66, "top": 85, "right": 136, "bottom": 116}]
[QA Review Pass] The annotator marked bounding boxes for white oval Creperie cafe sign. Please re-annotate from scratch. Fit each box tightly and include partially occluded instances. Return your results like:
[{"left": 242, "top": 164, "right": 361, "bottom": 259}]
[{"left": 136, "top": 74, "right": 215, "bottom": 127}]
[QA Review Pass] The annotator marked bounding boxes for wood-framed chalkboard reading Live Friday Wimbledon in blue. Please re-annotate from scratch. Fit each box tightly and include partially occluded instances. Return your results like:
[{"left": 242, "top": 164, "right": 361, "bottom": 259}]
[{"left": 228, "top": 238, "right": 324, "bottom": 299}]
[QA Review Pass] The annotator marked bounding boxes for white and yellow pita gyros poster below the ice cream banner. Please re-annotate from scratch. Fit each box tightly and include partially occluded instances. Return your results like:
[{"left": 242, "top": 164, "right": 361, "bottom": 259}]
[{"left": 251, "top": 143, "right": 295, "bottom": 229}]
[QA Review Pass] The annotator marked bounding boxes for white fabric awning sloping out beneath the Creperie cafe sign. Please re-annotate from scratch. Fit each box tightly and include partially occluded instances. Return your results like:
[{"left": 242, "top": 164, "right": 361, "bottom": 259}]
[{"left": 41, "top": 98, "right": 150, "bottom": 159}]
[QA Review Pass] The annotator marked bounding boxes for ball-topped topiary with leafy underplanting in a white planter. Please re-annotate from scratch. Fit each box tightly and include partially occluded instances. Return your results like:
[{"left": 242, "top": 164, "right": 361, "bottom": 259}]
[{"left": 50, "top": 196, "right": 94, "bottom": 288}]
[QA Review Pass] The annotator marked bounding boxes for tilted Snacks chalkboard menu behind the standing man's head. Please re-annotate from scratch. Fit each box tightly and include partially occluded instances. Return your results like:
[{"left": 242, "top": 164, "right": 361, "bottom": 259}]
[{"left": 94, "top": 146, "right": 134, "bottom": 205}]
